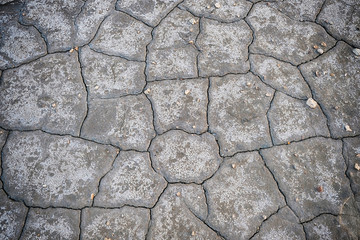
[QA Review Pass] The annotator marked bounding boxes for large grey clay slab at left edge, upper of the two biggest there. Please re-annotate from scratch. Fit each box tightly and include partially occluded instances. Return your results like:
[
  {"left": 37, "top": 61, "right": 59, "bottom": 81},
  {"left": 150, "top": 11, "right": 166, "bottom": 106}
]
[{"left": 0, "top": 53, "right": 86, "bottom": 135}]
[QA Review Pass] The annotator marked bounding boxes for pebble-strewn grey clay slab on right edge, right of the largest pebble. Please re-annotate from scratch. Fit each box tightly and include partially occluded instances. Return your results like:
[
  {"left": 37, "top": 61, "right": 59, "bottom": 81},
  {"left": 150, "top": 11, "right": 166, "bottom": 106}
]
[{"left": 300, "top": 42, "right": 360, "bottom": 138}]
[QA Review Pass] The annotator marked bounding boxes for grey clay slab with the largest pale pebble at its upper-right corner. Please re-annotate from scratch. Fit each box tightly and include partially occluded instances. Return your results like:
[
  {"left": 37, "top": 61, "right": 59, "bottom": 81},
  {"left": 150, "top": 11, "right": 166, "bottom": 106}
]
[{"left": 268, "top": 92, "right": 330, "bottom": 144}]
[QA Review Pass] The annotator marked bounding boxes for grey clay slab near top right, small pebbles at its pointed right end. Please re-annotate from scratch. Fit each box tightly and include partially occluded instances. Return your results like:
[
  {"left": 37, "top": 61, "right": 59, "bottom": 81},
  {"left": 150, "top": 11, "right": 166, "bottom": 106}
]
[{"left": 247, "top": 3, "right": 335, "bottom": 65}]
